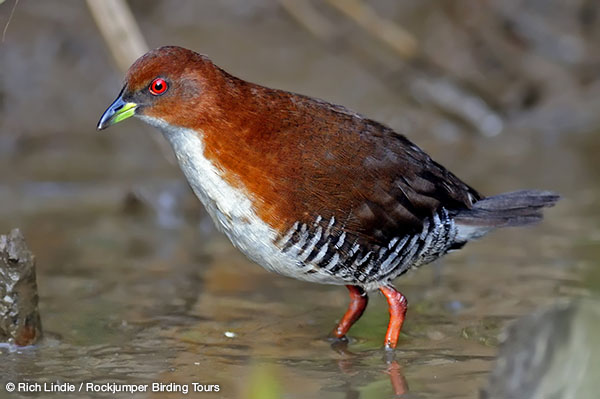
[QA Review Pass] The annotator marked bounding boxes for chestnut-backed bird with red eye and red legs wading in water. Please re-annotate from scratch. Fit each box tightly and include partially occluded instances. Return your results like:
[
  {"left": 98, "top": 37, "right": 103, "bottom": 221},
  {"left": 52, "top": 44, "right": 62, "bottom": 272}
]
[{"left": 97, "top": 46, "right": 560, "bottom": 351}]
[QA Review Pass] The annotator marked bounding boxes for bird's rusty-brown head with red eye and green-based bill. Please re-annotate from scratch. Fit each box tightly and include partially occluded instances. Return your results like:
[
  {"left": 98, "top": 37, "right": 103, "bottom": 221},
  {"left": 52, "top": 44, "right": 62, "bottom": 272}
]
[{"left": 97, "top": 46, "right": 224, "bottom": 130}]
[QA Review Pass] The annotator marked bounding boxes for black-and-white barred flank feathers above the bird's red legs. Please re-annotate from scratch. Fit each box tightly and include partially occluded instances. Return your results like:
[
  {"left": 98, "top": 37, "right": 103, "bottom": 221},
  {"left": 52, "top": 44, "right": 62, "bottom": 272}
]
[{"left": 278, "top": 209, "right": 457, "bottom": 285}]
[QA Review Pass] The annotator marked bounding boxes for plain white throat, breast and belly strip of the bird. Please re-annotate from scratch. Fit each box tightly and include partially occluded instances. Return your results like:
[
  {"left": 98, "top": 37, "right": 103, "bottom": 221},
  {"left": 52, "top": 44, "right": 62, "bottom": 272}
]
[{"left": 135, "top": 116, "right": 347, "bottom": 284}]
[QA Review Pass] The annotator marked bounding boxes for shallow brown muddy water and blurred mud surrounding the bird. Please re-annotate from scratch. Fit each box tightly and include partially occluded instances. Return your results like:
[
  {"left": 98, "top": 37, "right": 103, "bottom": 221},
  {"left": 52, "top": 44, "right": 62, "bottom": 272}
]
[{"left": 0, "top": 0, "right": 600, "bottom": 398}]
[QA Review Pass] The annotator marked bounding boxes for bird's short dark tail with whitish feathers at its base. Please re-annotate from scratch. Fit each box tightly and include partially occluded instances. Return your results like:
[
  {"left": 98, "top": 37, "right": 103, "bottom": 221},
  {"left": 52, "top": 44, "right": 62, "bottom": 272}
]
[{"left": 454, "top": 190, "right": 560, "bottom": 243}]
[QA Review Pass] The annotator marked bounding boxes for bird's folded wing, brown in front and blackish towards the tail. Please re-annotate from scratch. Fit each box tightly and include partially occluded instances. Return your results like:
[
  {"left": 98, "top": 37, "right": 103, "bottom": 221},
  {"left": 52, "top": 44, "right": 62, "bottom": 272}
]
[{"left": 272, "top": 97, "right": 481, "bottom": 245}]
